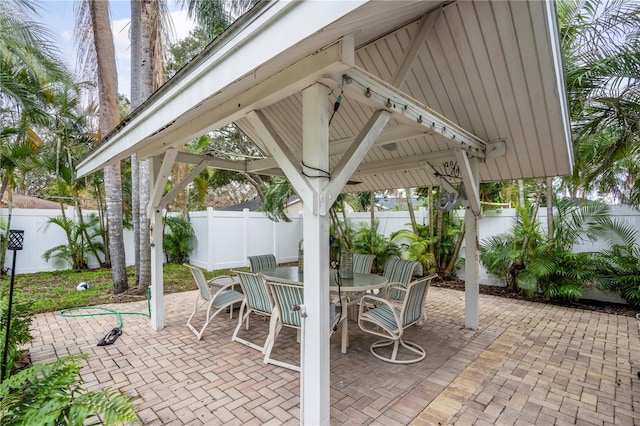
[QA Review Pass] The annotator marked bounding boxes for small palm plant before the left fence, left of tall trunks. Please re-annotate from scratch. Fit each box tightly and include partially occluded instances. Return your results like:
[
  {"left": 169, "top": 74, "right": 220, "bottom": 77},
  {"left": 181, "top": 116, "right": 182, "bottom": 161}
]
[{"left": 42, "top": 213, "right": 104, "bottom": 271}]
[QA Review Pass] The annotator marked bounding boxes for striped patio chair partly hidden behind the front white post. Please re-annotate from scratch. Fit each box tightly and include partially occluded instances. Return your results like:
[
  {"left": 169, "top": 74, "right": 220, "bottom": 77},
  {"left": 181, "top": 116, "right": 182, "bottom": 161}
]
[{"left": 264, "top": 279, "right": 347, "bottom": 372}]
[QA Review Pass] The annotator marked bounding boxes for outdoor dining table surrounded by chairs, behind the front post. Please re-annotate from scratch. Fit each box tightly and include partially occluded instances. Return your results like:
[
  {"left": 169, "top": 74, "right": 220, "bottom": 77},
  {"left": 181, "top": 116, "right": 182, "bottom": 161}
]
[{"left": 260, "top": 266, "right": 388, "bottom": 353}]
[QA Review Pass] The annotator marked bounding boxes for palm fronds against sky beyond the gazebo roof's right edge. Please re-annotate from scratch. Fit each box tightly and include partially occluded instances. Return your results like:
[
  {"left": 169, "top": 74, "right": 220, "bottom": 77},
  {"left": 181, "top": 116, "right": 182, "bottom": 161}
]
[{"left": 558, "top": 0, "right": 640, "bottom": 205}]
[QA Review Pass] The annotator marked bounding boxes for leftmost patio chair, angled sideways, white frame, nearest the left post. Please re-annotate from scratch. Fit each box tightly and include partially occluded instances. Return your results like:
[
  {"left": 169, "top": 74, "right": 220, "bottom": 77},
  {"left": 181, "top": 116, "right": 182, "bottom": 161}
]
[{"left": 185, "top": 265, "right": 244, "bottom": 340}]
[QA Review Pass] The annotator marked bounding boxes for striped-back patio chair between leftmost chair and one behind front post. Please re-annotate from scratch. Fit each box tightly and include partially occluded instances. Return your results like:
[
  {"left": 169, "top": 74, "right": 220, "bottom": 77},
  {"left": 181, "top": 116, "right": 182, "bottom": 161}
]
[{"left": 231, "top": 271, "right": 273, "bottom": 353}]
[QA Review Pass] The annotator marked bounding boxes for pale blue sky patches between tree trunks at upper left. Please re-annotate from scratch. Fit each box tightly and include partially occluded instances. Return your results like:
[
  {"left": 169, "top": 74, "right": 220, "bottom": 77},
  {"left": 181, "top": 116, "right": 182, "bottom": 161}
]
[{"left": 39, "top": 0, "right": 193, "bottom": 97}]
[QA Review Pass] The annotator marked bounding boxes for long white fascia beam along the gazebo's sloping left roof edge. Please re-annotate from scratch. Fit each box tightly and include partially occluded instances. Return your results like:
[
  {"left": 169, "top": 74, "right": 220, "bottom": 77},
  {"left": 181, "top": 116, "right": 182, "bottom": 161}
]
[{"left": 78, "top": 0, "right": 365, "bottom": 177}]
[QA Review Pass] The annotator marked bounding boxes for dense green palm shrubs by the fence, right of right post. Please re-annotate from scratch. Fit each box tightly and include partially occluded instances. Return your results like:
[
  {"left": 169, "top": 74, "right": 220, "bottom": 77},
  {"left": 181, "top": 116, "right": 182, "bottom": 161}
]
[{"left": 480, "top": 199, "right": 615, "bottom": 300}]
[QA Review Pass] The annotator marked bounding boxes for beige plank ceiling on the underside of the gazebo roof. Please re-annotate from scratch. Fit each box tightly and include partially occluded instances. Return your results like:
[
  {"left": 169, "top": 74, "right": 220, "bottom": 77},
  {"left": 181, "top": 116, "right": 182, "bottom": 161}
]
[{"left": 231, "top": 1, "right": 572, "bottom": 192}]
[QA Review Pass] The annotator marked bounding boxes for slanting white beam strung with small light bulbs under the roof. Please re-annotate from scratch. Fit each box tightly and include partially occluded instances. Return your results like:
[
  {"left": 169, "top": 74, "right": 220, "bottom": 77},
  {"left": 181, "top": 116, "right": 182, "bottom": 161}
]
[{"left": 334, "top": 67, "right": 487, "bottom": 159}]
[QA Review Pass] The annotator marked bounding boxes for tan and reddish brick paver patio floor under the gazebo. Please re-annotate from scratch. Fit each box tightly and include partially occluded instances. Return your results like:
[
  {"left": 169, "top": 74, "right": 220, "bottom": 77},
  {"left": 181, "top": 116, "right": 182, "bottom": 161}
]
[{"left": 30, "top": 287, "right": 640, "bottom": 426}]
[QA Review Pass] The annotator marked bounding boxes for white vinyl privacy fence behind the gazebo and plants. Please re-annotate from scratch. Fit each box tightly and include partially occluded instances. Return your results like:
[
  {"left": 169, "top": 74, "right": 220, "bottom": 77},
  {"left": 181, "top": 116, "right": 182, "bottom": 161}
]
[{"left": 0, "top": 206, "right": 640, "bottom": 284}]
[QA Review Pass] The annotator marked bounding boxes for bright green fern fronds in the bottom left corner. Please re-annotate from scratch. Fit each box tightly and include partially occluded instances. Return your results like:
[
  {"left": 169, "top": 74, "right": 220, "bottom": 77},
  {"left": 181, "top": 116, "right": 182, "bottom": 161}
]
[{"left": 0, "top": 354, "right": 138, "bottom": 426}]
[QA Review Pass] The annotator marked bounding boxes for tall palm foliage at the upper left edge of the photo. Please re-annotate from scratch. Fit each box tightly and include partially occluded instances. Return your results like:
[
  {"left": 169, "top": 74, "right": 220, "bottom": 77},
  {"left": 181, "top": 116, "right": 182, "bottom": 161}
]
[{"left": 0, "top": 0, "right": 69, "bottom": 272}]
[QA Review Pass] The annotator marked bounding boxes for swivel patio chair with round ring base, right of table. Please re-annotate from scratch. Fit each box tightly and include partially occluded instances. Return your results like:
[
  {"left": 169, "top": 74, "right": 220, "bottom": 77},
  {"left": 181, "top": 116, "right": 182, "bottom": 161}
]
[{"left": 358, "top": 275, "right": 435, "bottom": 364}]
